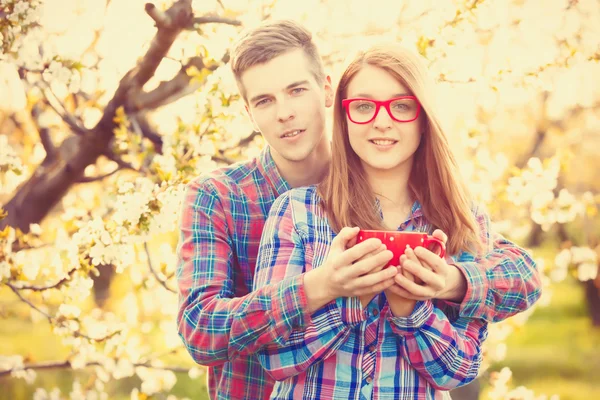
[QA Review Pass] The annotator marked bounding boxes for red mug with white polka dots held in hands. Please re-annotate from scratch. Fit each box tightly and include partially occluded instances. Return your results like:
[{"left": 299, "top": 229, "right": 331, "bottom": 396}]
[{"left": 356, "top": 229, "right": 446, "bottom": 267}]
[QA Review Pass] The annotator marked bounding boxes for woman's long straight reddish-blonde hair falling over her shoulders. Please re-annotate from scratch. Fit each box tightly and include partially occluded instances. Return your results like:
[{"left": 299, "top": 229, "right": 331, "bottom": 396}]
[{"left": 318, "top": 46, "right": 481, "bottom": 254}]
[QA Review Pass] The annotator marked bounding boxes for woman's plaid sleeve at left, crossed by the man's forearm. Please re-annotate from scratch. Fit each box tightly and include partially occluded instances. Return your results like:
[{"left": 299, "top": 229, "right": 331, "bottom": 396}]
[{"left": 254, "top": 195, "right": 365, "bottom": 380}]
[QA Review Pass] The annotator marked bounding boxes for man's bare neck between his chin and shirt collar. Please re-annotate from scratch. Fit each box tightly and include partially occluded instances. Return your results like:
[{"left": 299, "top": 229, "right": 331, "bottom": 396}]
[{"left": 273, "top": 138, "right": 331, "bottom": 188}]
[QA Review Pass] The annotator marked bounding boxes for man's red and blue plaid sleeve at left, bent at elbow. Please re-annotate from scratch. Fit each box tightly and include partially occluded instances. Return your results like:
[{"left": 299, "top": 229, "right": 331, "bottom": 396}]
[{"left": 177, "top": 180, "right": 308, "bottom": 366}]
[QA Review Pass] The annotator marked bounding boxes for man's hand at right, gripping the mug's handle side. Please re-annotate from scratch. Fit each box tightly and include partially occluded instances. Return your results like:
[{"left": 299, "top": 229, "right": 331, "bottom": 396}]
[{"left": 389, "top": 229, "right": 466, "bottom": 301}]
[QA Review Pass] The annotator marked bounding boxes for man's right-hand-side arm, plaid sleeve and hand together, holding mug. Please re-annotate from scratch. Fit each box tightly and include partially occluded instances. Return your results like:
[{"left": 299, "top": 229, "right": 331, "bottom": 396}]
[{"left": 391, "top": 209, "right": 541, "bottom": 322}]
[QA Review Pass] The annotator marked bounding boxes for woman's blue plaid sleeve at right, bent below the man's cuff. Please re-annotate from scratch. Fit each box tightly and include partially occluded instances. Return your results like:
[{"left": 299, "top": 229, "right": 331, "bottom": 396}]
[{"left": 386, "top": 300, "right": 487, "bottom": 390}]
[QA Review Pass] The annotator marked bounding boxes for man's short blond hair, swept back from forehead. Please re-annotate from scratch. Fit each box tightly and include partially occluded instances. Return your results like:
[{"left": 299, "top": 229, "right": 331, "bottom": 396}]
[{"left": 231, "top": 20, "right": 325, "bottom": 100}]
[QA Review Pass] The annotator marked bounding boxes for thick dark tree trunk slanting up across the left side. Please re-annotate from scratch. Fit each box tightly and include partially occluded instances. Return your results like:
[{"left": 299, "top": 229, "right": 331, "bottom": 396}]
[{"left": 0, "top": 0, "right": 193, "bottom": 232}]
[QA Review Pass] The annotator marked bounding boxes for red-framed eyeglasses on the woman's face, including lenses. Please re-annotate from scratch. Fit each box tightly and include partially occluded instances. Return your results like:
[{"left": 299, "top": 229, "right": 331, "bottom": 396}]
[{"left": 342, "top": 96, "right": 421, "bottom": 124}]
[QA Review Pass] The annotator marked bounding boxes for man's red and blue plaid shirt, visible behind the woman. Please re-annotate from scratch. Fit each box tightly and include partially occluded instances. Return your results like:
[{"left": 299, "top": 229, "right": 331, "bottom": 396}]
[{"left": 177, "top": 147, "right": 537, "bottom": 400}]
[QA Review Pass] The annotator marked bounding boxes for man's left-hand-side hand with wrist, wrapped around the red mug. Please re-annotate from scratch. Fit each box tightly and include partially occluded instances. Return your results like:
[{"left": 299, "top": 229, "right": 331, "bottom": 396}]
[{"left": 304, "top": 228, "right": 397, "bottom": 312}]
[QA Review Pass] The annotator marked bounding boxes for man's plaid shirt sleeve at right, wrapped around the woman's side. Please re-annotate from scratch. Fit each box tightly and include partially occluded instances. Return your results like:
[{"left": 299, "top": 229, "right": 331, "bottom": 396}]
[{"left": 447, "top": 209, "right": 541, "bottom": 322}]
